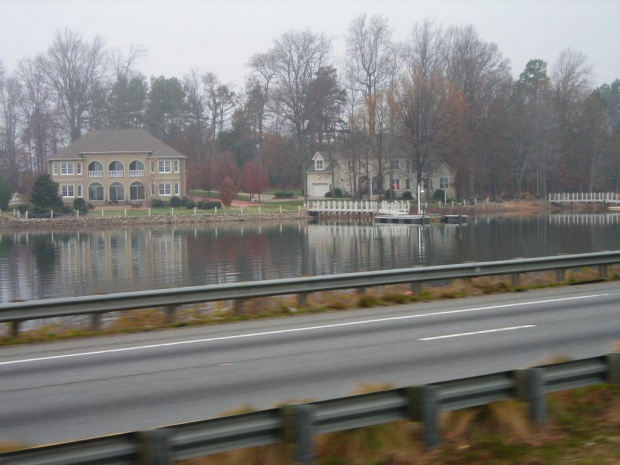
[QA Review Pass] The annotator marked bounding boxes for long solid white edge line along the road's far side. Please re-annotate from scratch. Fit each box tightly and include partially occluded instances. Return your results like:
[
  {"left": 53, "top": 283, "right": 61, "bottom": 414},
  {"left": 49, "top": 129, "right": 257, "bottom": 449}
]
[{"left": 0, "top": 294, "right": 612, "bottom": 366}]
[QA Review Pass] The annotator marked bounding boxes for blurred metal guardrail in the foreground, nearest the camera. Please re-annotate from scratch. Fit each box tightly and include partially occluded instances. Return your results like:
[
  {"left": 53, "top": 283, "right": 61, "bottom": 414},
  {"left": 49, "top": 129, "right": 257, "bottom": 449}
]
[{"left": 0, "top": 353, "right": 620, "bottom": 465}]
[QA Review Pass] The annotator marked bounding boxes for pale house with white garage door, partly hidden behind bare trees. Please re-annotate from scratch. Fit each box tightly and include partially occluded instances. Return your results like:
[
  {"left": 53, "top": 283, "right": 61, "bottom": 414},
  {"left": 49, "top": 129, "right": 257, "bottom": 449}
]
[{"left": 306, "top": 152, "right": 455, "bottom": 198}]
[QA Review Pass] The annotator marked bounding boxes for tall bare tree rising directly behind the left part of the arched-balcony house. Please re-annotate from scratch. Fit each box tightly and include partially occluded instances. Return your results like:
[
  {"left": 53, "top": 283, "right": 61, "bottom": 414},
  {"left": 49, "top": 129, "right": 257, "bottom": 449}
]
[{"left": 42, "top": 29, "right": 106, "bottom": 142}]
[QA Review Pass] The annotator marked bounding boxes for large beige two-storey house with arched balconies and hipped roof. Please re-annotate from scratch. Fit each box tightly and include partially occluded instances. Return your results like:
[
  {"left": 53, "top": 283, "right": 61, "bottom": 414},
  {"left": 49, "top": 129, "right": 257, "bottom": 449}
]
[{"left": 48, "top": 129, "right": 186, "bottom": 205}]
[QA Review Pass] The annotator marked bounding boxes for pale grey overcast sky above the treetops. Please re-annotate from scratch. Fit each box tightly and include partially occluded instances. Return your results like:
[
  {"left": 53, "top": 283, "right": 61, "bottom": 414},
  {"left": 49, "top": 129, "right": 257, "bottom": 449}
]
[{"left": 0, "top": 0, "right": 620, "bottom": 86}]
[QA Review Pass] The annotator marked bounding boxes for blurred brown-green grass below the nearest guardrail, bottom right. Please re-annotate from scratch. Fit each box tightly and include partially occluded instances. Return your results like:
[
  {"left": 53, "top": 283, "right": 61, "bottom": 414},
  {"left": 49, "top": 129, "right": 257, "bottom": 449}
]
[{"left": 170, "top": 385, "right": 620, "bottom": 465}]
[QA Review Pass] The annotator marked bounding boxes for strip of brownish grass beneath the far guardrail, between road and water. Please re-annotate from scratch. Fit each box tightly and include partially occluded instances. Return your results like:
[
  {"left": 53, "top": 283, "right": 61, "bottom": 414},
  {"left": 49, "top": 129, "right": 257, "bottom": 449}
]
[{"left": 0, "top": 266, "right": 620, "bottom": 346}]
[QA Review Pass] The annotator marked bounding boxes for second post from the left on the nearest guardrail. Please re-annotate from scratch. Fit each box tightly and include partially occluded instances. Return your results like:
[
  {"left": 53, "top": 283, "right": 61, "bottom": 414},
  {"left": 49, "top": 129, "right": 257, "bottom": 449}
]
[{"left": 282, "top": 404, "right": 316, "bottom": 465}]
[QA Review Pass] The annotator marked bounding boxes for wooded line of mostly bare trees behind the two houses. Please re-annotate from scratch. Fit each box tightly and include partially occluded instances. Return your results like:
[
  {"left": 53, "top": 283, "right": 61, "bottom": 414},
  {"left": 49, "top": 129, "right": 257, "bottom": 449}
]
[{"left": 0, "top": 15, "right": 620, "bottom": 198}]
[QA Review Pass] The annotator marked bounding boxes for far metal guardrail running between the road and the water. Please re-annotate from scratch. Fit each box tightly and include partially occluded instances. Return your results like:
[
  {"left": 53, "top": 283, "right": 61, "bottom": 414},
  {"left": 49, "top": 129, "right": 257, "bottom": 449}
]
[{"left": 0, "top": 251, "right": 620, "bottom": 334}]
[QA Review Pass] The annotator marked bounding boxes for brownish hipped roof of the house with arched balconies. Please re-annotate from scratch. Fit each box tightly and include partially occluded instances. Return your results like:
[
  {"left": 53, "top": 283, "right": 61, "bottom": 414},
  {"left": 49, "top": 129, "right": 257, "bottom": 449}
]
[{"left": 49, "top": 129, "right": 186, "bottom": 160}]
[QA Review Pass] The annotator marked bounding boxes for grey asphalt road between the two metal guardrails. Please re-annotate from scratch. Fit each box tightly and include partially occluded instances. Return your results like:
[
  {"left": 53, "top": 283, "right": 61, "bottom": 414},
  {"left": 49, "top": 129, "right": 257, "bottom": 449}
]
[{"left": 0, "top": 282, "right": 620, "bottom": 445}]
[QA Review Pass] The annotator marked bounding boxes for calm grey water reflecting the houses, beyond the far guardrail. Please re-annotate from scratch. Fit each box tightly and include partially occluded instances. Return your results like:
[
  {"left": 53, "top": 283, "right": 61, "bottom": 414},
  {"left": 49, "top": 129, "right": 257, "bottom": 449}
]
[{"left": 0, "top": 214, "right": 620, "bottom": 302}]
